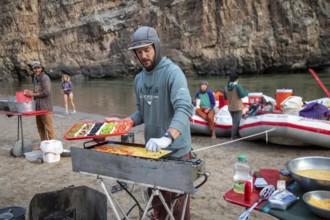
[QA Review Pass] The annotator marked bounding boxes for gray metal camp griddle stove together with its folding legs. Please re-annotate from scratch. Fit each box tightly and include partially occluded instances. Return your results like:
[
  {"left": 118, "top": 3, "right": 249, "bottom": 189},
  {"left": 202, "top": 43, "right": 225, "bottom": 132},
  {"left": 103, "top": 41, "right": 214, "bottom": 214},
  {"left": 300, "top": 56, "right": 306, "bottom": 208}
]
[{"left": 71, "top": 142, "right": 205, "bottom": 220}]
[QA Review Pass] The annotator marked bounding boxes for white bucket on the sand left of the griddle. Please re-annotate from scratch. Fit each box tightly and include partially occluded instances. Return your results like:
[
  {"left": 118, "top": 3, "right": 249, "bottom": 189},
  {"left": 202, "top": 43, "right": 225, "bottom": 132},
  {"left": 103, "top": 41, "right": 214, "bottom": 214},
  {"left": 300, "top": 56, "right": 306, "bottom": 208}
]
[{"left": 40, "top": 140, "right": 63, "bottom": 163}]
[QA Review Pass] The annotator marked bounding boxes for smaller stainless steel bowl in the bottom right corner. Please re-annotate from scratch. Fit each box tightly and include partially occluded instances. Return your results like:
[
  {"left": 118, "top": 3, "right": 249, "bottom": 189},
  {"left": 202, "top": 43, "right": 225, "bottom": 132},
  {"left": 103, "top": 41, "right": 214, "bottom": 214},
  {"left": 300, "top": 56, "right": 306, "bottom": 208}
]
[{"left": 303, "top": 190, "right": 330, "bottom": 219}]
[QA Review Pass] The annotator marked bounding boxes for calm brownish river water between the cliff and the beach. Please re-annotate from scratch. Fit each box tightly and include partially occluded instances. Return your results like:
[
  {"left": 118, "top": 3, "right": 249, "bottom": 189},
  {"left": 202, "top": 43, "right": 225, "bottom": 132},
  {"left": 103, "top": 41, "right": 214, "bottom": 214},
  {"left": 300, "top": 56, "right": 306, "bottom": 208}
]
[{"left": 0, "top": 70, "right": 330, "bottom": 118}]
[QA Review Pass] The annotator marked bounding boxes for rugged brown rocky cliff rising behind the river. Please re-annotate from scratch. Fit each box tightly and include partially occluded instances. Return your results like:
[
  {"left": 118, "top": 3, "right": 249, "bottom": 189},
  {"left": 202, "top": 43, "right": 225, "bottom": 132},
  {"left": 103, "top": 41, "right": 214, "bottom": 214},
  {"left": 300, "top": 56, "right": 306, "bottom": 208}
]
[{"left": 0, "top": 0, "right": 330, "bottom": 80}]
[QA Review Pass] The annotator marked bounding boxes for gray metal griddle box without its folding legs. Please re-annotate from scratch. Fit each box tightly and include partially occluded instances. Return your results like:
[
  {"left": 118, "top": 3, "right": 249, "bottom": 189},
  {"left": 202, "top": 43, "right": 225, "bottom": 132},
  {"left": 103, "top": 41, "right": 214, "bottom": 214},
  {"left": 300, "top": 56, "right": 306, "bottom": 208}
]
[{"left": 71, "top": 141, "right": 205, "bottom": 193}]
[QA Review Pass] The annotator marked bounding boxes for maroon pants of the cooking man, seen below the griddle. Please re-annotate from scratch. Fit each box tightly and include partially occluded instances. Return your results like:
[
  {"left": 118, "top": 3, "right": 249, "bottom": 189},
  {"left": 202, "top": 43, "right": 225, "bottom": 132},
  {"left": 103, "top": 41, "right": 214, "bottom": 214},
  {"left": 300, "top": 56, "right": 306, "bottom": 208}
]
[{"left": 148, "top": 153, "right": 191, "bottom": 220}]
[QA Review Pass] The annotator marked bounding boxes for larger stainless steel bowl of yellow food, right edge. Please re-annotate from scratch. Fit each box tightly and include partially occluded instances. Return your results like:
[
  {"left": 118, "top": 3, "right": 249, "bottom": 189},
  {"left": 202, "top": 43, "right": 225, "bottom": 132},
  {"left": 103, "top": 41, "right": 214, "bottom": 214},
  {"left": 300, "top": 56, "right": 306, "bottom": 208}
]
[{"left": 286, "top": 156, "right": 330, "bottom": 191}]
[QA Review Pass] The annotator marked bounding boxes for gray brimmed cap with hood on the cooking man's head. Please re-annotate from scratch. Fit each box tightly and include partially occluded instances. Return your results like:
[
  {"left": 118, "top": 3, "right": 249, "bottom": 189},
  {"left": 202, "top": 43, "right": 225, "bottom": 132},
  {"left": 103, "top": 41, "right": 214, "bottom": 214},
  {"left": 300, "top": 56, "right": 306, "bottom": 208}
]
[{"left": 128, "top": 26, "right": 159, "bottom": 50}]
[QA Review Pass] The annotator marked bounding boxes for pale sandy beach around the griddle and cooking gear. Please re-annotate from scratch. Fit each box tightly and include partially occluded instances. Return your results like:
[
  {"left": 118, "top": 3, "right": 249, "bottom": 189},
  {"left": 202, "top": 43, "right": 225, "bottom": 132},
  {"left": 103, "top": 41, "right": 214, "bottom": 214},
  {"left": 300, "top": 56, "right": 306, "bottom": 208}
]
[{"left": 0, "top": 101, "right": 330, "bottom": 220}]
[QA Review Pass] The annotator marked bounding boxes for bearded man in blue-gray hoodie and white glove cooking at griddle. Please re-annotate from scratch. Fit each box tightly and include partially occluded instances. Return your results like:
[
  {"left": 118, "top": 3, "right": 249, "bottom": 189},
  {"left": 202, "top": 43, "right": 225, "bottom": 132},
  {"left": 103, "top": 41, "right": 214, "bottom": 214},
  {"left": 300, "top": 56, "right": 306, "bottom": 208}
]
[{"left": 129, "top": 26, "right": 193, "bottom": 219}]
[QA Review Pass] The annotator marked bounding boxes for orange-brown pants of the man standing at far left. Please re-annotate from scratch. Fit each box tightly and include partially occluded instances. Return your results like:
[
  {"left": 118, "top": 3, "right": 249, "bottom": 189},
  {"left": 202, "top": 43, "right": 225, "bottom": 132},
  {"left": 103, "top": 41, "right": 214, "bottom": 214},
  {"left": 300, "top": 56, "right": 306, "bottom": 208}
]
[{"left": 36, "top": 114, "right": 55, "bottom": 141}]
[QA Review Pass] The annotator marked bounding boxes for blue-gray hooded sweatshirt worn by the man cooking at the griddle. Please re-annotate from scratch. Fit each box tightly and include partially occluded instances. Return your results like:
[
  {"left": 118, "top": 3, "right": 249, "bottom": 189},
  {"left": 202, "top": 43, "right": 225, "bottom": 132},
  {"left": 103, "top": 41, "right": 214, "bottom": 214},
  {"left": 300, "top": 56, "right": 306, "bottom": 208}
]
[{"left": 130, "top": 28, "right": 193, "bottom": 157}]
